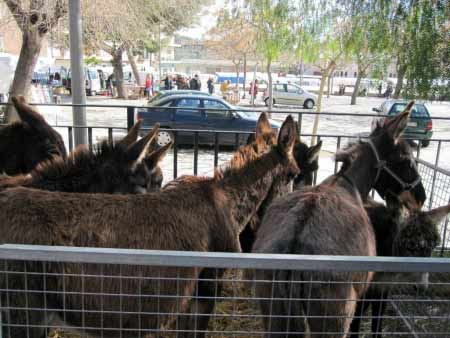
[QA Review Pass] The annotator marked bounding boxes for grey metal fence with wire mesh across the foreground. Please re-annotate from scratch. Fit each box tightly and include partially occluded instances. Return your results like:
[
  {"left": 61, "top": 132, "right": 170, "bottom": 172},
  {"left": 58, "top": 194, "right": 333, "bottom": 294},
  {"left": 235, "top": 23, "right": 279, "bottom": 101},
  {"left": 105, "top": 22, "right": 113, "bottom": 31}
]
[{"left": 0, "top": 245, "right": 450, "bottom": 338}]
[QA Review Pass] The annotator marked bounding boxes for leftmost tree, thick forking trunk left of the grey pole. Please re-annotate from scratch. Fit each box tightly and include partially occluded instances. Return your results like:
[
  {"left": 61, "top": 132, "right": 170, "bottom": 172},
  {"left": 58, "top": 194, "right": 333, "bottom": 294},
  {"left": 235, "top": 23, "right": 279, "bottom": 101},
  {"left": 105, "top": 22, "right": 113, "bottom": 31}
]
[{"left": 4, "top": 0, "right": 68, "bottom": 122}]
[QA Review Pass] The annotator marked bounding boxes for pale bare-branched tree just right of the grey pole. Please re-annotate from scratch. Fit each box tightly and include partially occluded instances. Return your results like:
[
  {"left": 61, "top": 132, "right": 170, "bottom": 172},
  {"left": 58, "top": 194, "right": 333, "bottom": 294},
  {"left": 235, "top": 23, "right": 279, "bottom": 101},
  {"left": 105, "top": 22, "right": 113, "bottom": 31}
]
[{"left": 83, "top": 0, "right": 208, "bottom": 98}]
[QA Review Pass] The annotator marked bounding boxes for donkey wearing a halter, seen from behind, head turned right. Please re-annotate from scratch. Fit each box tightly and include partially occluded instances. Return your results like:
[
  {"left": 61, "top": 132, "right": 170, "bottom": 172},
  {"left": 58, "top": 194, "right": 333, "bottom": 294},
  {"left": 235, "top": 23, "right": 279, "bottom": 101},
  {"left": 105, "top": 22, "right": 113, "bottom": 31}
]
[{"left": 253, "top": 103, "right": 423, "bottom": 338}]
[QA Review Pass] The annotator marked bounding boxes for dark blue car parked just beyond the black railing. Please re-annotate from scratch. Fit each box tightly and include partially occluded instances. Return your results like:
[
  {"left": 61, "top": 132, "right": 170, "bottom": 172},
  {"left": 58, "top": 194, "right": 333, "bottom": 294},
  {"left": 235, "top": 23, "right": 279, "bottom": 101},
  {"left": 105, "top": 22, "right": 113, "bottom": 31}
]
[{"left": 136, "top": 94, "right": 281, "bottom": 146}]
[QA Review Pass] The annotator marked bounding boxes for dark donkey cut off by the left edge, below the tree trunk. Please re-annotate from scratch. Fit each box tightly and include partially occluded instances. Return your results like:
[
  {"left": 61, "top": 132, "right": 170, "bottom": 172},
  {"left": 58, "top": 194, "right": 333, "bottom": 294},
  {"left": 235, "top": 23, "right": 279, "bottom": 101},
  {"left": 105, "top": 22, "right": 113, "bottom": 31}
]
[{"left": 0, "top": 96, "right": 67, "bottom": 175}]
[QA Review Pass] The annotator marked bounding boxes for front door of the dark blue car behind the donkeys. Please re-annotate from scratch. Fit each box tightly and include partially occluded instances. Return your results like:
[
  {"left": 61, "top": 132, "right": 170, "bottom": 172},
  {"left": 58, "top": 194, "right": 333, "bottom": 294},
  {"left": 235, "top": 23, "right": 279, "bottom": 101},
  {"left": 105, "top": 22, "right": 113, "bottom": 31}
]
[{"left": 203, "top": 99, "right": 240, "bottom": 145}]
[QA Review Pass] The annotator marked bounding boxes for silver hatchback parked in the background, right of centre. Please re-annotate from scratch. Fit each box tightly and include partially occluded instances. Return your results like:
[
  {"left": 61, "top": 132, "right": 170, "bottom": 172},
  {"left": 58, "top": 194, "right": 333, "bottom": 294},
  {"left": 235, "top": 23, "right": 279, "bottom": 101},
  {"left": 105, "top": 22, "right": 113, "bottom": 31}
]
[{"left": 263, "top": 83, "right": 317, "bottom": 109}]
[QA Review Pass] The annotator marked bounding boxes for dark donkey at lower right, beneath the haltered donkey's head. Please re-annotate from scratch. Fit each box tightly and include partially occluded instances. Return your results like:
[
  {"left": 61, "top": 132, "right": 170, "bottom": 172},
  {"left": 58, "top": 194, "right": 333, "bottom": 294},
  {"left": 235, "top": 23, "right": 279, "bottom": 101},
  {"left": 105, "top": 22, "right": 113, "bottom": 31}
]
[{"left": 350, "top": 198, "right": 442, "bottom": 338}]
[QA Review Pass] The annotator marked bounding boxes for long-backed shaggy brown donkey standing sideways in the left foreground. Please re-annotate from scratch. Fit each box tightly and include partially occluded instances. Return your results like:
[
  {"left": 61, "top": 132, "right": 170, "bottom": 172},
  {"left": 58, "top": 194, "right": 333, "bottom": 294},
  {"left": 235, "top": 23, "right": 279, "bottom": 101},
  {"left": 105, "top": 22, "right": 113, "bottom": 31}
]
[{"left": 0, "top": 116, "right": 299, "bottom": 337}]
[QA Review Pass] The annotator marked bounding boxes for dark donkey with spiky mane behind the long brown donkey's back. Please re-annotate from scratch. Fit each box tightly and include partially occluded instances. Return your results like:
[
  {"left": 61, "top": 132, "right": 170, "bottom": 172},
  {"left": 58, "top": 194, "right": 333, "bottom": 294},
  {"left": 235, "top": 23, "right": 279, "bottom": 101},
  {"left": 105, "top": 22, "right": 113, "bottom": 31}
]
[{"left": 0, "top": 122, "right": 171, "bottom": 194}]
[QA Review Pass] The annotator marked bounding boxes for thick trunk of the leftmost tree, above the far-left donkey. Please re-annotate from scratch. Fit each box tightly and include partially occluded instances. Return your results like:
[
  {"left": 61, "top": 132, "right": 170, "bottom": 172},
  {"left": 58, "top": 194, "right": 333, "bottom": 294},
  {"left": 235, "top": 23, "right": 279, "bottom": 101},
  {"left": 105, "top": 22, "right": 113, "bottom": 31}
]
[{"left": 6, "top": 31, "right": 42, "bottom": 122}]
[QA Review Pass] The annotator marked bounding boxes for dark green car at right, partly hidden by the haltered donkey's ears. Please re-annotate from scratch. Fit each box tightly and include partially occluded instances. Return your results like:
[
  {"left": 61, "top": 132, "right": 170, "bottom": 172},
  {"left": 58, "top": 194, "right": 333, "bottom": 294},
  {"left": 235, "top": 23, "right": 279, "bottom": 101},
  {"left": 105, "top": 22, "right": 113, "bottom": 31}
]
[{"left": 372, "top": 100, "right": 433, "bottom": 147}]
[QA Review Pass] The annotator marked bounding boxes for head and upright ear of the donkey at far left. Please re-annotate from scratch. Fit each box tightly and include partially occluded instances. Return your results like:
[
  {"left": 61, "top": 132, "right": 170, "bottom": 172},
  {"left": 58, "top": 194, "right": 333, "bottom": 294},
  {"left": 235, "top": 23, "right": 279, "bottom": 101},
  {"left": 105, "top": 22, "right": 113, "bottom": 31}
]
[{"left": 11, "top": 96, "right": 67, "bottom": 172}]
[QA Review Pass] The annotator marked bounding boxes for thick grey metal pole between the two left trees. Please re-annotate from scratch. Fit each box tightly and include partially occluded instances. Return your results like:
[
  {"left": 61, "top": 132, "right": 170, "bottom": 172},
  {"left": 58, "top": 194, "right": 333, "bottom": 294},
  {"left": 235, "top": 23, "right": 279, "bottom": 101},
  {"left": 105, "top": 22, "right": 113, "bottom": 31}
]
[{"left": 69, "top": 0, "right": 87, "bottom": 146}]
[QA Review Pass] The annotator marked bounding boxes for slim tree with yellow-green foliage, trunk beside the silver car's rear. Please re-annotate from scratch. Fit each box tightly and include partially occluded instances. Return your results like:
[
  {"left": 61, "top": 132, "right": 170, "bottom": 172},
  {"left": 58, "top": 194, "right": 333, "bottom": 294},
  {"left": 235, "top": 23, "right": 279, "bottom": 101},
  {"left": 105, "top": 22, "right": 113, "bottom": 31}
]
[{"left": 248, "top": 0, "right": 291, "bottom": 110}]
